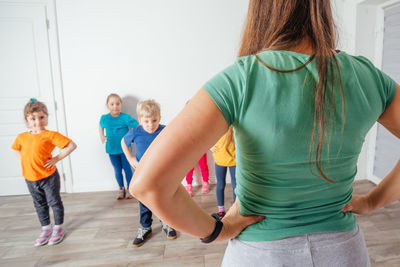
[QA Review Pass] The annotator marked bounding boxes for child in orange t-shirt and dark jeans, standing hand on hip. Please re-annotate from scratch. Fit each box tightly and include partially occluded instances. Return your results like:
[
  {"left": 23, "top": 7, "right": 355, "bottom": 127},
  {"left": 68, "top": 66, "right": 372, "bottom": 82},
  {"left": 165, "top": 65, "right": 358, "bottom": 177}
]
[{"left": 11, "top": 98, "right": 76, "bottom": 246}]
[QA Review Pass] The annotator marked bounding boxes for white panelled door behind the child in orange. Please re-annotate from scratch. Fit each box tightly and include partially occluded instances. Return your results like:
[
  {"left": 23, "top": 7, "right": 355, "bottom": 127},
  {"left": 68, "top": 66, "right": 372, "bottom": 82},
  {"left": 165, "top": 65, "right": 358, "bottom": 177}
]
[{"left": 0, "top": 2, "right": 65, "bottom": 195}]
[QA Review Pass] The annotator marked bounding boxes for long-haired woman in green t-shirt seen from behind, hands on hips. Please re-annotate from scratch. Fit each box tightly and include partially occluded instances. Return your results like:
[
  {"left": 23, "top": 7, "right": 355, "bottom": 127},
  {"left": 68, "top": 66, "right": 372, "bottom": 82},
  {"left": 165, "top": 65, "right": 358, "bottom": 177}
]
[{"left": 126, "top": 0, "right": 400, "bottom": 267}]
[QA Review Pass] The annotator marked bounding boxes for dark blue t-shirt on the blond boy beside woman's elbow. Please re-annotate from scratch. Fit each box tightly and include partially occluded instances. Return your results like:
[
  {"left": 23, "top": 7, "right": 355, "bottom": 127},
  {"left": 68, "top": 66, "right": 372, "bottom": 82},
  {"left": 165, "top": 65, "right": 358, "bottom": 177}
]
[{"left": 124, "top": 124, "right": 165, "bottom": 161}]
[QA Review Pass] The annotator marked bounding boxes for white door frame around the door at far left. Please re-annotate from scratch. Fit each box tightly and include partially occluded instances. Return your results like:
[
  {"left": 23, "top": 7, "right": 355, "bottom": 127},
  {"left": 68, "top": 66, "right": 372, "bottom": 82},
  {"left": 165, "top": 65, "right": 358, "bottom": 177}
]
[{"left": 0, "top": 0, "right": 73, "bottom": 193}]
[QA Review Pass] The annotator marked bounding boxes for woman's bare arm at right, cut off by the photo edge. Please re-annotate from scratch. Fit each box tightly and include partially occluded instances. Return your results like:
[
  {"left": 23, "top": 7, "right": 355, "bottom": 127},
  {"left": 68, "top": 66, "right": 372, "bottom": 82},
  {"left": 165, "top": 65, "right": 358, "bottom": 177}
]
[{"left": 343, "top": 84, "right": 400, "bottom": 215}]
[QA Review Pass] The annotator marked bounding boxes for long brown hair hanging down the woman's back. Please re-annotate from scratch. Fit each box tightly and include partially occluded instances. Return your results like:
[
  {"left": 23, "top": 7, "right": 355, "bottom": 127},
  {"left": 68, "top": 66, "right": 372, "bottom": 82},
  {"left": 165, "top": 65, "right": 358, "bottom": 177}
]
[{"left": 227, "top": 0, "right": 345, "bottom": 183}]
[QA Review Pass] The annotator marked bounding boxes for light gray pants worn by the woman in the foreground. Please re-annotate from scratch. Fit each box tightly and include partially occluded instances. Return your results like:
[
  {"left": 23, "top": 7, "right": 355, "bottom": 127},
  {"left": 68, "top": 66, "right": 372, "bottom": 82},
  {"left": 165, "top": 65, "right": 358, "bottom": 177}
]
[{"left": 222, "top": 226, "right": 371, "bottom": 267}]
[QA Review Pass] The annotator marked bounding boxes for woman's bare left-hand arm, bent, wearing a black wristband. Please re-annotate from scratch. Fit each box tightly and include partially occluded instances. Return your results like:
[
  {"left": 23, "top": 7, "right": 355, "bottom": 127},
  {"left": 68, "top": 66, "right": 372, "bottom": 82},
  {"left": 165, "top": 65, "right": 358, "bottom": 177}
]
[{"left": 129, "top": 89, "right": 261, "bottom": 240}]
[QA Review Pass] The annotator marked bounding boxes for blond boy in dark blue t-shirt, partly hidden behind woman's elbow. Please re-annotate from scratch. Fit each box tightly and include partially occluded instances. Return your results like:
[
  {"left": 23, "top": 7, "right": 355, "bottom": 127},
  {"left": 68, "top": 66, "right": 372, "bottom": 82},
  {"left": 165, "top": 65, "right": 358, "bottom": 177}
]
[{"left": 121, "top": 100, "right": 176, "bottom": 247}]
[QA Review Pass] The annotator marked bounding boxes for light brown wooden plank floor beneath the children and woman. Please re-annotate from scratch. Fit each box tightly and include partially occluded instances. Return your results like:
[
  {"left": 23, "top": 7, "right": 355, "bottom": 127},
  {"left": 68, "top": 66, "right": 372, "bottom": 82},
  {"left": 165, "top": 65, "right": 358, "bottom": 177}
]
[{"left": 0, "top": 181, "right": 400, "bottom": 267}]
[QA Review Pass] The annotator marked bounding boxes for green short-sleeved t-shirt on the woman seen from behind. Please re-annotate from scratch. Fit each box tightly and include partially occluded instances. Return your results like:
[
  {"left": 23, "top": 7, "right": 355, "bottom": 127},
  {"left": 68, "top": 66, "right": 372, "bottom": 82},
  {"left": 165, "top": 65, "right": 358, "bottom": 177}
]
[{"left": 204, "top": 51, "right": 396, "bottom": 241}]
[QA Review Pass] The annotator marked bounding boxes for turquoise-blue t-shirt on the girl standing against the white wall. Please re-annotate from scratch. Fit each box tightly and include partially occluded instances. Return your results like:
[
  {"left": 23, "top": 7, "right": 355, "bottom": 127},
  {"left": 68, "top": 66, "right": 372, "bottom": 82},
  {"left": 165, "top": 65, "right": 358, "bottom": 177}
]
[{"left": 100, "top": 113, "right": 139, "bottom": 155}]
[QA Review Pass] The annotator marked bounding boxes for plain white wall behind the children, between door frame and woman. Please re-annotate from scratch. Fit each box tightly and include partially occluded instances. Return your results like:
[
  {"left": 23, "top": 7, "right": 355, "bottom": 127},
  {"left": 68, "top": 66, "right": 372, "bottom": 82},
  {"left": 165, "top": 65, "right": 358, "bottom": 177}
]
[{"left": 56, "top": 0, "right": 248, "bottom": 192}]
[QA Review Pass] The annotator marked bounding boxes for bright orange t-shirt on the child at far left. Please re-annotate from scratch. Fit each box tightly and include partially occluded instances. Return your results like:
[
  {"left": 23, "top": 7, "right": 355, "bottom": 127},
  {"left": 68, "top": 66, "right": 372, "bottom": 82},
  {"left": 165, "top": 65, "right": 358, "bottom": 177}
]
[{"left": 11, "top": 130, "right": 71, "bottom": 182}]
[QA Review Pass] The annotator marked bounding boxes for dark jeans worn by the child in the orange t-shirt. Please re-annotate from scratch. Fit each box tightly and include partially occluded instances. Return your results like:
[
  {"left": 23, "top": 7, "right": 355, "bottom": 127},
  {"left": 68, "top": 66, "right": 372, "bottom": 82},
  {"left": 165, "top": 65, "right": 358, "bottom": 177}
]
[{"left": 25, "top": 170, "right": 64, "bottom": 226}]
